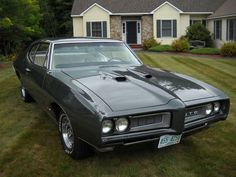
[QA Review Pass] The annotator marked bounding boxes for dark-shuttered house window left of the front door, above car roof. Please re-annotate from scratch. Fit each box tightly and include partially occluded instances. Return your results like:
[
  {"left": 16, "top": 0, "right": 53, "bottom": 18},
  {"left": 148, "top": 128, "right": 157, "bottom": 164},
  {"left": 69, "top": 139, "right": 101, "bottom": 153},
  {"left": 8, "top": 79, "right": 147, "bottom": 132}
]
[{"left": 86, "top": 21, "right": 107, "bottom": 38}]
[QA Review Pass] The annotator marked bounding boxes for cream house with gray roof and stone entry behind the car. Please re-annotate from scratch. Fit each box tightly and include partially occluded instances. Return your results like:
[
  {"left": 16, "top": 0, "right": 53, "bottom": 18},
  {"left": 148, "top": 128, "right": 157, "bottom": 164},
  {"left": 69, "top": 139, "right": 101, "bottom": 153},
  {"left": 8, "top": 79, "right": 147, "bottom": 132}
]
[{"left": 71, "top": 0, "right": 236, "bottom": 45}]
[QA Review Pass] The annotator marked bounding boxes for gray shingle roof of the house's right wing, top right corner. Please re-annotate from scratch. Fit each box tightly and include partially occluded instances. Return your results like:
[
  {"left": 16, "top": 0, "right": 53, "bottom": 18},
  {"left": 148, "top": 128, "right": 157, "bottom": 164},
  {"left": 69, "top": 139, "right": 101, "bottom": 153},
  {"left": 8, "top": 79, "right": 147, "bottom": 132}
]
[{"left": 209, "top": 0, "right": 236, "bottom": 18}]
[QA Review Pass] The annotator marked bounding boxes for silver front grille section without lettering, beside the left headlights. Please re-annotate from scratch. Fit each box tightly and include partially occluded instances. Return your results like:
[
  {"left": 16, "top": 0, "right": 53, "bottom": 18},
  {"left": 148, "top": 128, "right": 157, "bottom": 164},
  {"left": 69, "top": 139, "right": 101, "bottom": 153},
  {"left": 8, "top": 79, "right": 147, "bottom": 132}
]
[{"left": 130, "top": 112, "right": 171, "bottom": 132}]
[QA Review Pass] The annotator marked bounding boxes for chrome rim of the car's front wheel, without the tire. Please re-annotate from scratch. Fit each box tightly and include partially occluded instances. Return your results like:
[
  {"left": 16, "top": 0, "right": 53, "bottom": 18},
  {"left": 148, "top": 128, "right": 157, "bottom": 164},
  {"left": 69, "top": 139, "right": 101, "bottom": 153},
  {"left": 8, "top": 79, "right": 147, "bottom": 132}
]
[{"left": 61, "top": 115, "right": 74, "bottom": 150}]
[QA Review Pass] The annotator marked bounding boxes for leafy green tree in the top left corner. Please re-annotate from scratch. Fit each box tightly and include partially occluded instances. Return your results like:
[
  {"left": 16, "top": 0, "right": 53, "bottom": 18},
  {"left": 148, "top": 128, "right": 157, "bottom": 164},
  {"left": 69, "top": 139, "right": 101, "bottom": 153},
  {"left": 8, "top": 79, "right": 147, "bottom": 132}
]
[{"left": 0, "top": 0, "right": 42, "bottom": 55}]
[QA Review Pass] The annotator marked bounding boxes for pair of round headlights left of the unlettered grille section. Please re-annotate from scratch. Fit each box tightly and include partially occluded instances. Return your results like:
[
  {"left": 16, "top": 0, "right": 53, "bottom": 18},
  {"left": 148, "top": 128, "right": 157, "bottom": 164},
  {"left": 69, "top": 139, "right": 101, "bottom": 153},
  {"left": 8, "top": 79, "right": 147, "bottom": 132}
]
[{"left": 102, "top": 118, "right": 129, "bottom": 134}]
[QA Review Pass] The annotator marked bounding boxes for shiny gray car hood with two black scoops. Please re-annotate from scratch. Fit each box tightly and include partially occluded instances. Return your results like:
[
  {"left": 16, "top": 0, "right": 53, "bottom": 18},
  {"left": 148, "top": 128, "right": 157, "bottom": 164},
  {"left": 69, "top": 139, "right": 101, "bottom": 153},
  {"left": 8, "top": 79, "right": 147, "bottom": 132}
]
[{"left": 63, "top": 66, "right": 216, "bottom": 111}]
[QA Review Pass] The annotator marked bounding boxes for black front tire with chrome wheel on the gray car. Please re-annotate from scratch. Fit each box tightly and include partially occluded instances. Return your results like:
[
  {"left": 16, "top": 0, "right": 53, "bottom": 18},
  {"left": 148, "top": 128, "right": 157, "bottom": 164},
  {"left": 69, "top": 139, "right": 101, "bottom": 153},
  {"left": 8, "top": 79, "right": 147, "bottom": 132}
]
[{"left": 58, "top": 112, "right": 94, "bottom": 160}]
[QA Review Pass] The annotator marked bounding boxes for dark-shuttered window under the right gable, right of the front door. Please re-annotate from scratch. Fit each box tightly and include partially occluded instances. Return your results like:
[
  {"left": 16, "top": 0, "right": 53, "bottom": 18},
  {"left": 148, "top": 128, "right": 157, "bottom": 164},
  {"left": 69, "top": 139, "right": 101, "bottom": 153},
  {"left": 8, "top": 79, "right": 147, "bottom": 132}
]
[{"left": 157, "top": 20, "right": 177, "bottom": 38}]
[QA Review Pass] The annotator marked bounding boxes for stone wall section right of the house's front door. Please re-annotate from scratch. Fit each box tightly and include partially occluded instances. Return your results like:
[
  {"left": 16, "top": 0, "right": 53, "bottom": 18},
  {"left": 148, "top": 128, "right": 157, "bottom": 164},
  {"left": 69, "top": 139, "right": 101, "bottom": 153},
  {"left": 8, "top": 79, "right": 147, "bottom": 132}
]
[{"left": 141, "top": 15, "right": 153, "bottom": 43}]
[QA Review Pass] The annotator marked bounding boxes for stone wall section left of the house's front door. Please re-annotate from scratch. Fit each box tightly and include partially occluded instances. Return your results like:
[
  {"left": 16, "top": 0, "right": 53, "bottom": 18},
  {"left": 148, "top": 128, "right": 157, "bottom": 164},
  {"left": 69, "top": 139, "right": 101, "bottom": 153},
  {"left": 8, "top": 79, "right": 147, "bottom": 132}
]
[{"left": 110, "top": 16, "right": 122, "bottom": 40}]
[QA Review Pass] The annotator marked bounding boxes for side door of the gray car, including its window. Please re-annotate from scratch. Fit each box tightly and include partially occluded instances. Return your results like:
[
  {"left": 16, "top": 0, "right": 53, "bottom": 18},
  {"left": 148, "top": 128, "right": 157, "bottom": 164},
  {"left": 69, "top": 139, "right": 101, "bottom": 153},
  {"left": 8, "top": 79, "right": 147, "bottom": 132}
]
[{"left": 25, "top": 43, "right": 49, "bottom": 104}]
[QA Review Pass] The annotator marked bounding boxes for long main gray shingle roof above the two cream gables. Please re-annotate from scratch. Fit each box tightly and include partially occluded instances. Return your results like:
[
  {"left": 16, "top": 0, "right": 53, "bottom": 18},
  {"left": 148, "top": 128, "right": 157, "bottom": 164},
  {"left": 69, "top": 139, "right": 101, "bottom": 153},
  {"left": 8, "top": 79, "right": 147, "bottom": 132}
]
[{"left": 71, "top": 0, "right": 226, "bottom": 15}]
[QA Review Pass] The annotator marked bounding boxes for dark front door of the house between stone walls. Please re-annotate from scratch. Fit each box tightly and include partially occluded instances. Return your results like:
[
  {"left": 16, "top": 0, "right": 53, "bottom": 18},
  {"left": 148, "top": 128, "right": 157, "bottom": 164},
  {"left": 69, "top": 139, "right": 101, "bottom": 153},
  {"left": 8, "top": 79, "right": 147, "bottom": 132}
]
[{"left": 126, "top": 21, "right": 137, "bottom": 44}]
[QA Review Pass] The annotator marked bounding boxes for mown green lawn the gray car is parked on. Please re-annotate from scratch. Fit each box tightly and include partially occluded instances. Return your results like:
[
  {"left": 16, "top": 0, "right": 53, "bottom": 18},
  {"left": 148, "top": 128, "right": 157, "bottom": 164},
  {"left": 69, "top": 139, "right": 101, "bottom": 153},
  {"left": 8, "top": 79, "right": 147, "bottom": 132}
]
[{"left": 0, "top": 52, "right": 236, "bottom": 177}]
